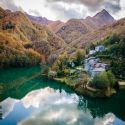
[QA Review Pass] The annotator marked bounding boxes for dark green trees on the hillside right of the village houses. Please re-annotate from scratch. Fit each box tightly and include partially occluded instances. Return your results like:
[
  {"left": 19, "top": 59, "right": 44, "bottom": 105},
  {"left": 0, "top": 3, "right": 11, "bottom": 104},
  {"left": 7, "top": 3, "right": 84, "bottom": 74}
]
[{"left": 95, "top": 34, "right": 125, "bottom": 79}]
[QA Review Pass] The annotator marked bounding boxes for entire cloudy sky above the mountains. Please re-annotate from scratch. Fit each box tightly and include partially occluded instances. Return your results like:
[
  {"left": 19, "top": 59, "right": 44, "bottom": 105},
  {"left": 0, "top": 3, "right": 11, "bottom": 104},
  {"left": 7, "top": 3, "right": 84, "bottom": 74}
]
[{"left": 0, "top": 0, "right": 125, "bottom": 21}]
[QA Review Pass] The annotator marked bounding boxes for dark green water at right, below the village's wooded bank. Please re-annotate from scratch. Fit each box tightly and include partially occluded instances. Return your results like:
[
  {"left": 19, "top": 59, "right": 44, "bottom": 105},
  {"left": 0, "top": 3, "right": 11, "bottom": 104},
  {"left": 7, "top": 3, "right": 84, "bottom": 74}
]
[{"left": 78, "top": 94, "right": 125, "bottom": 121}]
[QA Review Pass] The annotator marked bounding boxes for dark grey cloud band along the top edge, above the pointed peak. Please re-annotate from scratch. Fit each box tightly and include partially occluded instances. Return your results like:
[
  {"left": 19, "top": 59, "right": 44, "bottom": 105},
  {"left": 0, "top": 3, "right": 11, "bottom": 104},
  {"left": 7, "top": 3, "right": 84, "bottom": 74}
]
[{"left": 47, "top": 0, "right": 121, "bottom": 13}]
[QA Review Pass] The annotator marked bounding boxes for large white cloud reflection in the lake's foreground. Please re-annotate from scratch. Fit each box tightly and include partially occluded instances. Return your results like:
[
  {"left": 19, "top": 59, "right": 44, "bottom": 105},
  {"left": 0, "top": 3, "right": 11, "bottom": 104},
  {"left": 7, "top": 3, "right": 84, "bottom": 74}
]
[{"left": 19, "top": 88, "right": 115, "bottom": 125}]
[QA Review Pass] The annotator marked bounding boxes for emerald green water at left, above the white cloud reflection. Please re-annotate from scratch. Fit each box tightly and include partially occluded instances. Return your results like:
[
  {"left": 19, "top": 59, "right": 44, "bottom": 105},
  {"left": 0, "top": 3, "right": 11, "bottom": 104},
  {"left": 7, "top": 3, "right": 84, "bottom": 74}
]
[{"left": 0, "top": 67, "right": 72, "bottom": 101}]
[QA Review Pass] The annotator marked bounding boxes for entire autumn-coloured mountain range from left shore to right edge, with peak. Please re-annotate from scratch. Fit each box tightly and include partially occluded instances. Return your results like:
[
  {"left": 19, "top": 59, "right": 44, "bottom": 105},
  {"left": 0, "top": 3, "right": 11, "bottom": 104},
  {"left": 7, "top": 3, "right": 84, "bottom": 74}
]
[{"left": 0, "top": 8, "right": 125, "bottom": 66}]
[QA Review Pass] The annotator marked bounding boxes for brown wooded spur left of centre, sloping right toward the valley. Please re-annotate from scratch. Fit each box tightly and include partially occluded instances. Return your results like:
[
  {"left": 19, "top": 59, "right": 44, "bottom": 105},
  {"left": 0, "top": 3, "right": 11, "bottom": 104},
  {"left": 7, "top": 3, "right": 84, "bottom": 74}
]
[{"left": 32, "top": 24, "right": 66, "bottom": 56}]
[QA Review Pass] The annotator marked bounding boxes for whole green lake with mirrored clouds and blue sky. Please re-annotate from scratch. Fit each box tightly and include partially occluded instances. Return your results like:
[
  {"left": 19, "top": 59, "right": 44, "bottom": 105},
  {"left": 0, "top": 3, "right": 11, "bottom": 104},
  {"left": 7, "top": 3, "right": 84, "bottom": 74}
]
[{"left": 0, "top": 67, "right": 125, "bottom": 125}]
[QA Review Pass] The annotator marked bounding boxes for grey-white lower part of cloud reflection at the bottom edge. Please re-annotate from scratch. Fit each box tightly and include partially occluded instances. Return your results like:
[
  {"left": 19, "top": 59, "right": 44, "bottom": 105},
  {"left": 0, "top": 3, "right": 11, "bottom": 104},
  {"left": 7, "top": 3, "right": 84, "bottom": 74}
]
[{"left": 18, "top": 104, "right": 94, "bottom": 125}]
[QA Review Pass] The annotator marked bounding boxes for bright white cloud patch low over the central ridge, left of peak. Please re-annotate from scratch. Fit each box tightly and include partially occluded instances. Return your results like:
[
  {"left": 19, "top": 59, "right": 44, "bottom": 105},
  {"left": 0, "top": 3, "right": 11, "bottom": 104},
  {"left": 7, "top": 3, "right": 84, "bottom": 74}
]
[{"left": 46, "top": 2, "right": 86, "bottom": 21}]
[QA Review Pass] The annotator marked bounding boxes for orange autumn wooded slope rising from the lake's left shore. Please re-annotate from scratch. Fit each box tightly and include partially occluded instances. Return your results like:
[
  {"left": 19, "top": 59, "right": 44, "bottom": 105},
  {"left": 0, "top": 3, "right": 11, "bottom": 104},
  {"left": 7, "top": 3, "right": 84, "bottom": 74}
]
[{"left": 0, "top": 31, "right": 40, "bottom": 68}]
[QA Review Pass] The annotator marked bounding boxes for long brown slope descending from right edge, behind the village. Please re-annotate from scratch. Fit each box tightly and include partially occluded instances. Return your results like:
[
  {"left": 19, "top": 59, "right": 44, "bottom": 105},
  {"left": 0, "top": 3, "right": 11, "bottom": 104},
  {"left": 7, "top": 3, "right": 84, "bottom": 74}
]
[{"left": 71, "top": 18, "right": 125, "bottom": 48}]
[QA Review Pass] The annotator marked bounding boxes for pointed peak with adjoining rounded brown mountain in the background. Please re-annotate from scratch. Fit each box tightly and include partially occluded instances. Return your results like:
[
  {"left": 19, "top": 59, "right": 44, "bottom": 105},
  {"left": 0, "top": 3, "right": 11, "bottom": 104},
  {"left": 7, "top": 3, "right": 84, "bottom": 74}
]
[{"left": 56, "top": 10, "right": 115, "bottom": 44}]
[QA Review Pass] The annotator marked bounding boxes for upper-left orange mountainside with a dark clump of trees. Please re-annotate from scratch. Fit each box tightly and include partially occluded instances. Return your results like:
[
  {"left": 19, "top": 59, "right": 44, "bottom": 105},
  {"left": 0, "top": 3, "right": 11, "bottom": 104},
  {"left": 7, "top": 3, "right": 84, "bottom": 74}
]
[{"left": 0, "top": 10, "right": 36, "bottom": 43}]
